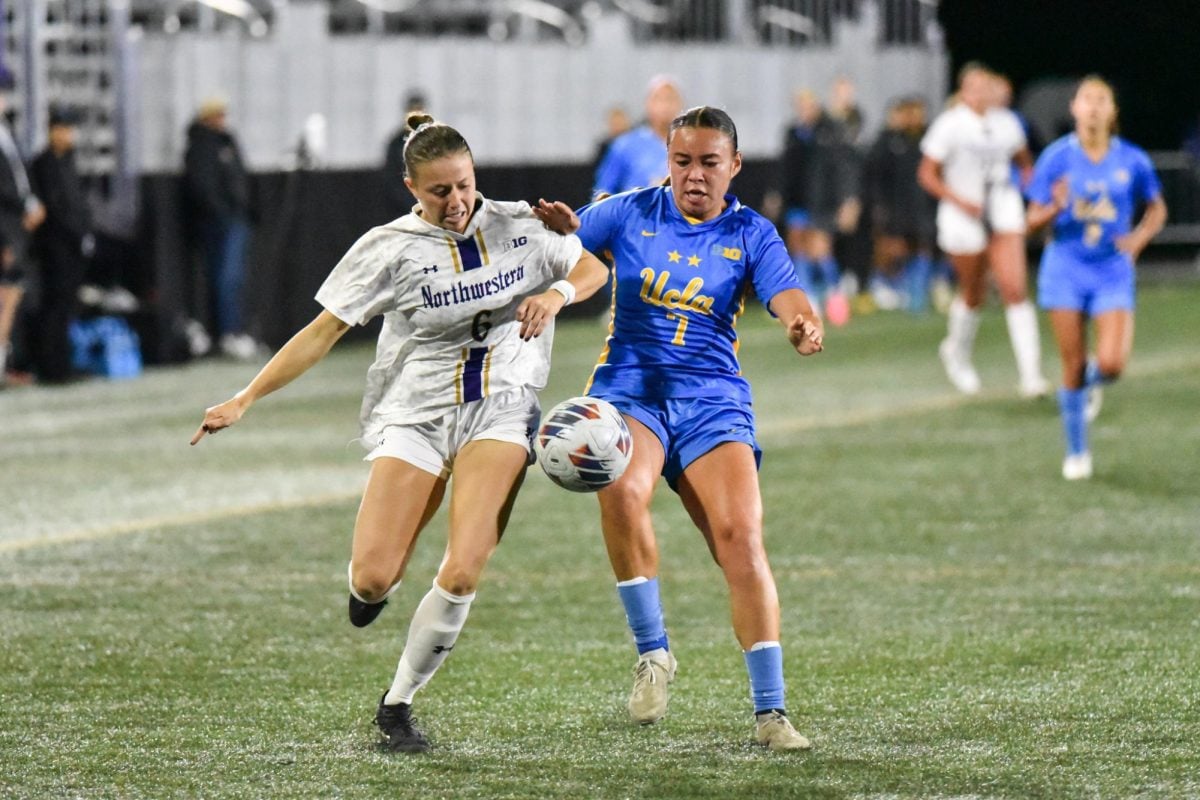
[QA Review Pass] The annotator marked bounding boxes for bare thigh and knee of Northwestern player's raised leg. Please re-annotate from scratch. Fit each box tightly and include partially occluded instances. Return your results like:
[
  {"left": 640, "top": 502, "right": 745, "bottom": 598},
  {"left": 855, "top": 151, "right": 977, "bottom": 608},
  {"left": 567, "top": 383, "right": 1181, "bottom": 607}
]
[{"left": 350, "top": 456, "right": 445, "bottom": 589}]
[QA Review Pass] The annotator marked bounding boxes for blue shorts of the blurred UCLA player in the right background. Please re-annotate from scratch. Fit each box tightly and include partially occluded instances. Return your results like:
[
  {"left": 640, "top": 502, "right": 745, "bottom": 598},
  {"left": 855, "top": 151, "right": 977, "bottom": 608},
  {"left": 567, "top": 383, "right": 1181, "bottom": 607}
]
[{"left": 1038, "top": 243, "right": 1136, "bottom": 317}]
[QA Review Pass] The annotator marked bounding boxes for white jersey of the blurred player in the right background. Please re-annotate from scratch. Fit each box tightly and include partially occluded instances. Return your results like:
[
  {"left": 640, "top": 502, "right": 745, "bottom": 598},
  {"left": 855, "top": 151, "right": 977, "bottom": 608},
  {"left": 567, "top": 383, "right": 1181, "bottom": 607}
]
[{"left": 920, "top": 103, "right": 1025, "bottom": 205}]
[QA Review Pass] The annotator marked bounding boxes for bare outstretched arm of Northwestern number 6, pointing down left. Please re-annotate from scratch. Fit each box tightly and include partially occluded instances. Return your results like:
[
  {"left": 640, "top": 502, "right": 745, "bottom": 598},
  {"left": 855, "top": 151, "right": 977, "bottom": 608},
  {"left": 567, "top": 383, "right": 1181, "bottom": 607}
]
[{"left": 192, "top": 311, "right": 350, "bottom": 445}]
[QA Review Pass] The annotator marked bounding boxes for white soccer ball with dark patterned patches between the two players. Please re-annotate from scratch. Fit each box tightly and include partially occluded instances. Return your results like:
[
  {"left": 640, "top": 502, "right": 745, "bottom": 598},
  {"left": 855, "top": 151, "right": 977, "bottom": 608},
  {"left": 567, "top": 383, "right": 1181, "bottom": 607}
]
[{"left": 534, "top": 397, "right": 634, "bottom": 492}]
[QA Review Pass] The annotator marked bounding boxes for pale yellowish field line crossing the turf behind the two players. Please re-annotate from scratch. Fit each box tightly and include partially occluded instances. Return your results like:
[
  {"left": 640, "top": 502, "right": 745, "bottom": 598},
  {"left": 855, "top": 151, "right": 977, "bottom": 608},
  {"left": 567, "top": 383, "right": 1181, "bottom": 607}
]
[{"left": 7, "top": 356, "right": 1200, "bottom": 554}]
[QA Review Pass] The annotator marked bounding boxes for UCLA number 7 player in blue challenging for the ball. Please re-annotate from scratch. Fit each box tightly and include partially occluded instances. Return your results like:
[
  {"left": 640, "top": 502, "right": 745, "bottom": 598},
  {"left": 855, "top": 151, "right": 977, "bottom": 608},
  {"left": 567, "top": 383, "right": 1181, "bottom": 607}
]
[{"left": 535, "top": 107, "right": 823, "bottom": 750}]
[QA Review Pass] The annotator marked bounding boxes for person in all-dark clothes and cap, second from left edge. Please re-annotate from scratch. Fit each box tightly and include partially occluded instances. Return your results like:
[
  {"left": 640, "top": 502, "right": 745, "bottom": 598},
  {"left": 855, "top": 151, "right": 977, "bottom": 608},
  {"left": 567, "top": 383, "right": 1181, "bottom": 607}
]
[{"left": 30, "top": 108, "right": 95, "bottom": 383}]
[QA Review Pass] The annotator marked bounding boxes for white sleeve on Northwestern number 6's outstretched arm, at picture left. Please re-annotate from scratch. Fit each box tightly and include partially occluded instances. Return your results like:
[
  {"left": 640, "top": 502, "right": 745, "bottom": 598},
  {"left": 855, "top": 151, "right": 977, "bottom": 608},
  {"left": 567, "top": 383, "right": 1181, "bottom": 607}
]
[{"left": 317, "top": 228, "right": 403, "bottom": 325}]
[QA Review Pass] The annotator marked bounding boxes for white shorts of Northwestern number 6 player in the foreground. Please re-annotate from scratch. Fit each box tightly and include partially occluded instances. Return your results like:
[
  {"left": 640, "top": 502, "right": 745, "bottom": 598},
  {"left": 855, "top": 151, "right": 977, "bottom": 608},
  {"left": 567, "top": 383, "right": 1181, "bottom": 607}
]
[{"left": 365, "top": 387, "right": 541, "bottom": 479}]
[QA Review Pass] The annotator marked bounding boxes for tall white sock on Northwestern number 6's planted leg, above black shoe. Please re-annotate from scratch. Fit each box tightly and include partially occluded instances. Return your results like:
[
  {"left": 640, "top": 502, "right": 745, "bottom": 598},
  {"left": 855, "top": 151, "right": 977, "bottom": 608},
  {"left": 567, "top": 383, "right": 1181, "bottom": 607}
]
[{"left": 383, "top": 581, "right": 475, "bottom": 705}]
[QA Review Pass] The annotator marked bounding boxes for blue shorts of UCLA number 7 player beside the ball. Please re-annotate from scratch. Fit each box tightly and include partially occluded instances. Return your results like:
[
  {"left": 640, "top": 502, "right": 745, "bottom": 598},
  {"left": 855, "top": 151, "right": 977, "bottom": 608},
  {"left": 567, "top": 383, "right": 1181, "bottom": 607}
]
[{"left": 604, "top": 397, "right": 762, "bottom": 492}]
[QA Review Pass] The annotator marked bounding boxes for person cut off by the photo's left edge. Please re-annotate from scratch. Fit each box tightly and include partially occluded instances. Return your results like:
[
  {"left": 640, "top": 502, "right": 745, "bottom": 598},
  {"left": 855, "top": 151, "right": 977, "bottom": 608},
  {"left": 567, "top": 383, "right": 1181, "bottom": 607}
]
[{"left": 0, "top": 72, "right": 46, "bottom": 385}]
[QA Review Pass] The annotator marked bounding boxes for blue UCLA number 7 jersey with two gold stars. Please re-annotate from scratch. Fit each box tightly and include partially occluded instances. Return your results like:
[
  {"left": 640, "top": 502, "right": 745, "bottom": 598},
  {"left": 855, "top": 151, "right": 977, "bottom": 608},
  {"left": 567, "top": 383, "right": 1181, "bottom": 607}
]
[{"left": 578, "top": 186, "right": 800, "bottom": 403}]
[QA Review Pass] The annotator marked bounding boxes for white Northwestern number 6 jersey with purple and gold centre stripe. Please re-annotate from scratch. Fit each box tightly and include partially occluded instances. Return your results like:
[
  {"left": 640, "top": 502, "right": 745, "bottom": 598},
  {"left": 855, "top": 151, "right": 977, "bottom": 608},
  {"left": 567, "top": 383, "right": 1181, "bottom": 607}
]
[{"left": 317, "top": 196, "right": 583, "bottom": 445}]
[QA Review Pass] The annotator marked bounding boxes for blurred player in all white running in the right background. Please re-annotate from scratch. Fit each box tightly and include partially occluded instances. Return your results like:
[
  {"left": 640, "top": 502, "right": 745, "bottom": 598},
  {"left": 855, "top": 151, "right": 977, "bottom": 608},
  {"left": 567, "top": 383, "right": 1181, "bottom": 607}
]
[{"left": 917, "top": 64, "right": 1050, "bottom": 397}]
